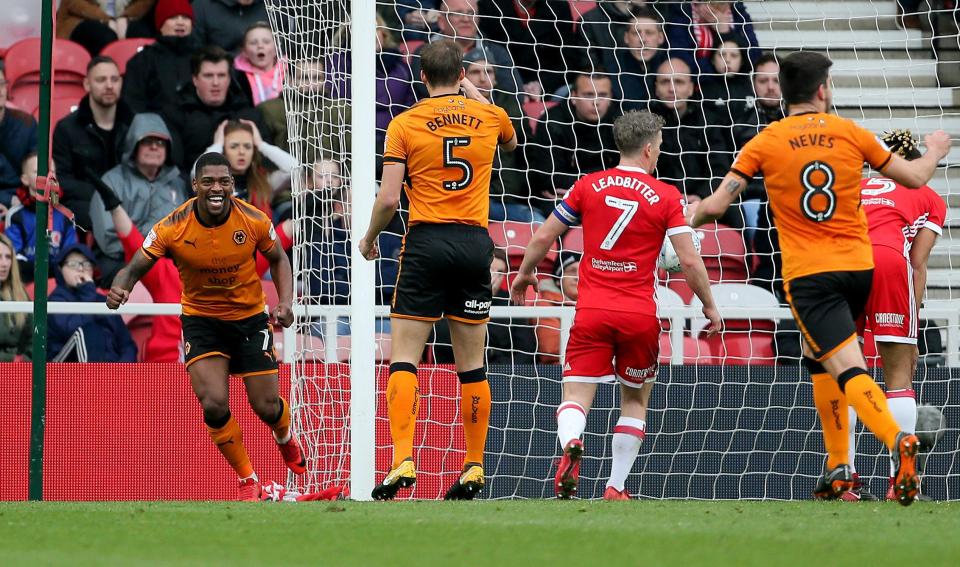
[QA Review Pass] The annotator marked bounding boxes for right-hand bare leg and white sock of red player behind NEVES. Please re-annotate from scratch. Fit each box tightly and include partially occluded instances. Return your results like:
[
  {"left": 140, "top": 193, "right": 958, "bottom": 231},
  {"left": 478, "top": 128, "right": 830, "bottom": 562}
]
[{"left": 877, "top": 341, "right": 917, "bottom": 500}]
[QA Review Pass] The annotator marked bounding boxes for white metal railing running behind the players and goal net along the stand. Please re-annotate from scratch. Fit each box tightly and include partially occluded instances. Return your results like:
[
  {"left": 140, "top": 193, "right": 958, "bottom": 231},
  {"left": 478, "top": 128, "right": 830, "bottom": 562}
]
[{"left": 0, "top": 300, "right": 960, "bottom": 367}]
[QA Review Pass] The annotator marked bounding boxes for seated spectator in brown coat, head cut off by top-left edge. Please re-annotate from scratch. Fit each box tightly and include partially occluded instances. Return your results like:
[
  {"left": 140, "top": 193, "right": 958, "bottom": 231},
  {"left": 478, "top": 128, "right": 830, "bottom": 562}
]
[{"left": 57, "top": 0, "right": 156, "bottom": 56}]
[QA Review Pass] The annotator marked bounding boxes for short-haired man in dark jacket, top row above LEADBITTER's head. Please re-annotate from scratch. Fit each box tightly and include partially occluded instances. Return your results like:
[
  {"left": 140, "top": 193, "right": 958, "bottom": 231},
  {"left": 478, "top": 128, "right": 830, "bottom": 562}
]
[{"left": 605, "top": 8, "right": 667, "bottom": 112}]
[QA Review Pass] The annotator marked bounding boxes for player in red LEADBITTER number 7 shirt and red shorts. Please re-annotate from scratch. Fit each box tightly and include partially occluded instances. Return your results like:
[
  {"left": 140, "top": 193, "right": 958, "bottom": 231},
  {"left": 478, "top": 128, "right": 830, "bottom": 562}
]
[{"left": 511, "top": 112, "right": 720, "bottom": 500}]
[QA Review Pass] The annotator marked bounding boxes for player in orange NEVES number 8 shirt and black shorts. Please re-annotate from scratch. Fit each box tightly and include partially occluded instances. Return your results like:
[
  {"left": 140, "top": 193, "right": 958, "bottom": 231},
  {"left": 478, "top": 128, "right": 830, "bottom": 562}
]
[{"left": 691, "top": 51, "right": 950, "bottom": 505}]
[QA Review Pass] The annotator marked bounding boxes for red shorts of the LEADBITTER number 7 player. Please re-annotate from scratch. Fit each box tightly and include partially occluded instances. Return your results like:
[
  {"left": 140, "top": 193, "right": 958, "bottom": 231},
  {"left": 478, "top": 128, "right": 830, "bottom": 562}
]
[{"left": 563, "top": 309, "right": 660, "bottom": 388}]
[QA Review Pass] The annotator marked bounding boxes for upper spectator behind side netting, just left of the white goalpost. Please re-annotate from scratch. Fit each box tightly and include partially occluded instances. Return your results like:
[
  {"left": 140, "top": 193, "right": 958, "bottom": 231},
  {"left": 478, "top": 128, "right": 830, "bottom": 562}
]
[{"left": 257, "top": 59, "right": 351, "bottom": 163}]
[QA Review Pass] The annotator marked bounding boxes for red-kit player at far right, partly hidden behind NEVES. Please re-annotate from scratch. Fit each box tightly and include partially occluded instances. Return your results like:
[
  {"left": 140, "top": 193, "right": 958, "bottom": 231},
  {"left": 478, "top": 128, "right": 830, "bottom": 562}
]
[{"left": 844, "top": 130, "right": 947, "bottom": 500}]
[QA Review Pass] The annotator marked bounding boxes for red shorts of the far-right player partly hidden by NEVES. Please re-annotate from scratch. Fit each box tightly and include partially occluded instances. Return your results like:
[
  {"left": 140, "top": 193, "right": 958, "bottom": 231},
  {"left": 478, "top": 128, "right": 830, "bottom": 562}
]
[{"left": 864, "top": 246, "right": 917, "bottom": 344}]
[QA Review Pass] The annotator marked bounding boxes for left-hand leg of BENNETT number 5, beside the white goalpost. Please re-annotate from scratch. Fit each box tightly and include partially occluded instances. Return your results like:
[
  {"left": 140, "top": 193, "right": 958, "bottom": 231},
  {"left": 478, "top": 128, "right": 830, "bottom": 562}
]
[{"left": 372, "top": 315, "right": 433, "bottom": 500}]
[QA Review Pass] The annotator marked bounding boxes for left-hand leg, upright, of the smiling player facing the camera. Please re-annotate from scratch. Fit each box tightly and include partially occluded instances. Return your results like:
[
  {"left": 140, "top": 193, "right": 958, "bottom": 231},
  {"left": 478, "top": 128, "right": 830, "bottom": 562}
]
[{"left": 187, "top": 355, "right": 260, "bottom": 501}]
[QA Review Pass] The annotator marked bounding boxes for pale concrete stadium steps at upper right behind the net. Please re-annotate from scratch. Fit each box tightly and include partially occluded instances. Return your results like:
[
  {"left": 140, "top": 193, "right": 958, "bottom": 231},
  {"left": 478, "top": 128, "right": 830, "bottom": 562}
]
[{"left": 746, "top": 0, "right": 960, "bottom": 300}]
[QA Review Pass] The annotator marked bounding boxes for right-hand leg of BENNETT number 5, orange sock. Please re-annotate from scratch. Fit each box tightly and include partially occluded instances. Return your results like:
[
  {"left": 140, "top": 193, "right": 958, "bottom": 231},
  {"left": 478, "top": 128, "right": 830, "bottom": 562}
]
[{"left": 444, "top": 316, "right": 491, "bottom": 500}]
